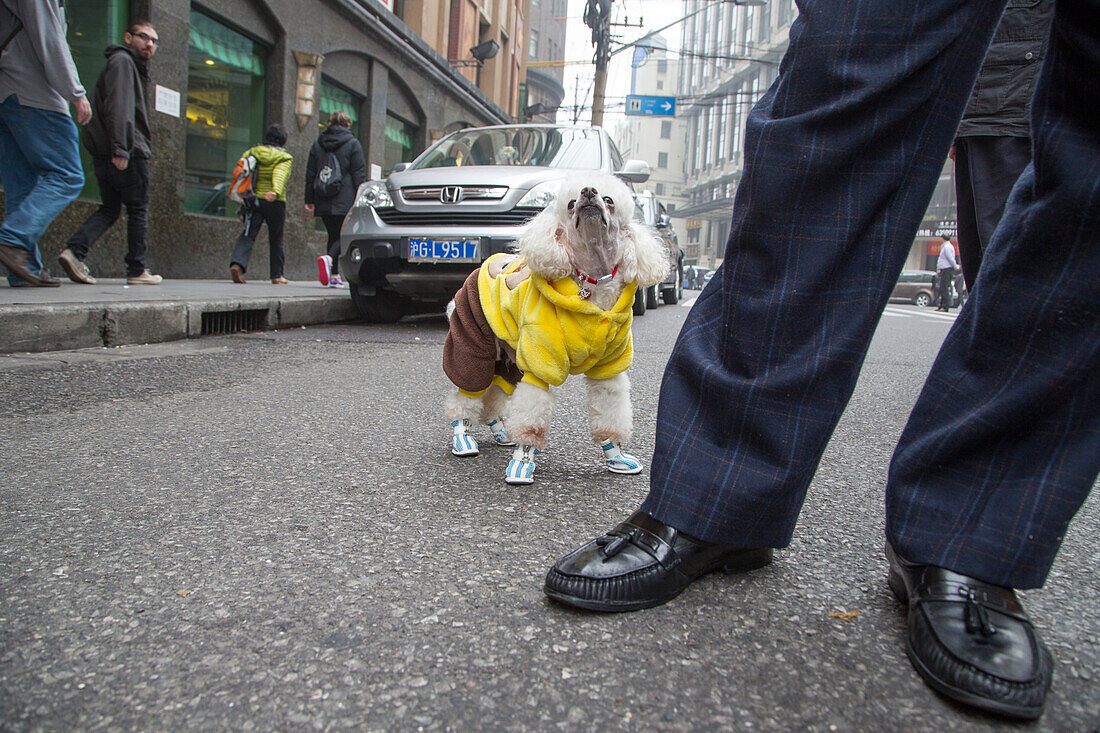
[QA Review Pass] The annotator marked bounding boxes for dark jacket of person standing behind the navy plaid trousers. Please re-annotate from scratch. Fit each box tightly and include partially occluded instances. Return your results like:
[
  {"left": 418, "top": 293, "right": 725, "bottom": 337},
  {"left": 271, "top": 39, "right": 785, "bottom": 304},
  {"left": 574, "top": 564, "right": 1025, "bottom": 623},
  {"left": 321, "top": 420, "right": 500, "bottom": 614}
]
[{"left": 957, "top": 0, "right": 1054, "bottom": 138}]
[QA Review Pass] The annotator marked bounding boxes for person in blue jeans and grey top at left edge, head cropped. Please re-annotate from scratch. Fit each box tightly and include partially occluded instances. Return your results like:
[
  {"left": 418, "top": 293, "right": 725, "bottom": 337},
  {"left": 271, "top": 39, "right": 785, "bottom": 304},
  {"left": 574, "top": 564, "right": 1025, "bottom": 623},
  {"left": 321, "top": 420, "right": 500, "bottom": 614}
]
[{"left": 0, "top": 0, "right": 91, "bottom": 287}]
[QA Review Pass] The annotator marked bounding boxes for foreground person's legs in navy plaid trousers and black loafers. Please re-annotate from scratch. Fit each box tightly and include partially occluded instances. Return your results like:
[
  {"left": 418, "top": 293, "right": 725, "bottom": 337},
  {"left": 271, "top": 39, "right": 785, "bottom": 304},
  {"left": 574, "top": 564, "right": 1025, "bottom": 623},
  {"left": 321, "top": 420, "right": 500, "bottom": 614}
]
[{"left": 546, "top": 0, "right": 1100, "bottom": 727}]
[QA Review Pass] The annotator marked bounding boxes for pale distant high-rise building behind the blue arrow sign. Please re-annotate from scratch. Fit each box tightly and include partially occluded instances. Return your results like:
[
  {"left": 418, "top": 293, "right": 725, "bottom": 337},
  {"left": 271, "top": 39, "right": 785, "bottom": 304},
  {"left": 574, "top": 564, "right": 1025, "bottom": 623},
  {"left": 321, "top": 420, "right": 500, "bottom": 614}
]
[{"left": 615, "top": 35, "right": 682, "bottom": 250}]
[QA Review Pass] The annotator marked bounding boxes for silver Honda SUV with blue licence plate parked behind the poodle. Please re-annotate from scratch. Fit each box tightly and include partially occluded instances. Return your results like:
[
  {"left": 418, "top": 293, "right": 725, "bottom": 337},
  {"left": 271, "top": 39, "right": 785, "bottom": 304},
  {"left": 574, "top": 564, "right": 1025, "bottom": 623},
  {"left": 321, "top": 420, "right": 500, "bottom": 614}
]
[{"left": 340, "top": 124, "right": 649, "bottom": 322}]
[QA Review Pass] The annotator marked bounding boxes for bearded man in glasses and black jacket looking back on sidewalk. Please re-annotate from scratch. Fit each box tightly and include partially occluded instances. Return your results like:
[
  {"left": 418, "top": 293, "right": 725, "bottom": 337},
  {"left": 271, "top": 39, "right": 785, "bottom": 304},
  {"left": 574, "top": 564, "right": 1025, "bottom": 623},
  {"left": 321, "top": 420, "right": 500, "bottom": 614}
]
[{"left": 57, "top": 21, "right": 162, "bottom": 285}]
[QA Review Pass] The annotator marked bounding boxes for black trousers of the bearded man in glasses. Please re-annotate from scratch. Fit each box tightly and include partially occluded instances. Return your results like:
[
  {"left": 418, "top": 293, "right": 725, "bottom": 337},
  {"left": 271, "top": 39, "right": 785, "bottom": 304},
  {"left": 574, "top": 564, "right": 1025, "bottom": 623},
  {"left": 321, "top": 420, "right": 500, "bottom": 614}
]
[{"left": 68, "top": 157, "right": 149, "bottom": 277}]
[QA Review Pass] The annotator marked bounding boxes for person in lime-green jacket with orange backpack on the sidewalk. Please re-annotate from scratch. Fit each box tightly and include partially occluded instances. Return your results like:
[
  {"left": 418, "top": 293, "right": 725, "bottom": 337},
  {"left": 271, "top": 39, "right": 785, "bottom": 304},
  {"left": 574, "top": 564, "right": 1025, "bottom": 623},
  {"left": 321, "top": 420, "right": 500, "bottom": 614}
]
[{"left": 229, "top": 124, "right": 294, "bottom": 285}]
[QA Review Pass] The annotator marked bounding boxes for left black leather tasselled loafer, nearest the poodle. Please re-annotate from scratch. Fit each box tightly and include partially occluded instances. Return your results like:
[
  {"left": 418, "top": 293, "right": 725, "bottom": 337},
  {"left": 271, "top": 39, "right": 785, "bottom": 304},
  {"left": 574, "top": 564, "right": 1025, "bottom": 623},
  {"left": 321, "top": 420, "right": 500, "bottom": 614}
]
[{"left": 543, "top": 511, "right": 772, "bottom": 612}]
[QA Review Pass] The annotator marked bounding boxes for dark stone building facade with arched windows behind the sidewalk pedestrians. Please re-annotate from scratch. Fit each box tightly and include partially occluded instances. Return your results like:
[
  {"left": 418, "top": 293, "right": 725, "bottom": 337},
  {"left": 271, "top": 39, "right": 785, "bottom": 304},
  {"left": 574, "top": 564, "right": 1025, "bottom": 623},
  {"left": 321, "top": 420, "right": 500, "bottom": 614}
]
[{"left": 15, "top": 0, "right": 529, "bottom": 280}]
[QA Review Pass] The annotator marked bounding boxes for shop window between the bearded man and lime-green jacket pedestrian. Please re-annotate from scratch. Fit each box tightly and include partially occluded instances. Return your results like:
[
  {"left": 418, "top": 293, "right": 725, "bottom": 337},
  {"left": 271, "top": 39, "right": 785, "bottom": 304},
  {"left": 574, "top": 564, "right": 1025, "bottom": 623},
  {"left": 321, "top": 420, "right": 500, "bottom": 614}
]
[{"left": 184, "top": 10, "right": 267, "bottom": 216}]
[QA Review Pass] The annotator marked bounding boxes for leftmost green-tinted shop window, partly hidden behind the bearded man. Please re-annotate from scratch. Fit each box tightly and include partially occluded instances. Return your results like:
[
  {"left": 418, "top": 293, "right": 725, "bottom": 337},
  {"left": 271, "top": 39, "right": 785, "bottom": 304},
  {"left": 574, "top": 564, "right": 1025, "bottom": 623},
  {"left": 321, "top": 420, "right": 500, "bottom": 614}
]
[{"left": 65, "top": 0, "right": 130, "bottom": 199}]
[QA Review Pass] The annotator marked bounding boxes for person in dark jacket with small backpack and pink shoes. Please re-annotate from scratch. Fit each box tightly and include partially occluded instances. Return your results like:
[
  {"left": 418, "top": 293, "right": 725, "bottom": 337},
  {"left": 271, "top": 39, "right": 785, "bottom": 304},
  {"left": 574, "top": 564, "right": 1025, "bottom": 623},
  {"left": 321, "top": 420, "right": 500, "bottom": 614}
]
[{"left": 305, "top": 111, "right": 366, "bottom": 287}]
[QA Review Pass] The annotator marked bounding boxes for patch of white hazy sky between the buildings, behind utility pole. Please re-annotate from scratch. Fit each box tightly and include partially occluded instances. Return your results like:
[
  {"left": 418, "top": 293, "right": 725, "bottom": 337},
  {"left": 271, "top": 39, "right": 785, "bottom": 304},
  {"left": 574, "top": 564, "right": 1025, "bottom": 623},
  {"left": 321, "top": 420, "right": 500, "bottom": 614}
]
[{"left": 558, "top": 0, "right": 685, "bottom": 129}]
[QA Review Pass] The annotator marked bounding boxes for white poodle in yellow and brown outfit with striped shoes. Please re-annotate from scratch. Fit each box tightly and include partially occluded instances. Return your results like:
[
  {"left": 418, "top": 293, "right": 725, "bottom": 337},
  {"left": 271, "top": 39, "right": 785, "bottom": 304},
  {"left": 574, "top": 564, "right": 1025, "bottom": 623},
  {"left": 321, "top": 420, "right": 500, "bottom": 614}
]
[{"left": 443, "top": 174, "right": 670, "bottom": 483}]
